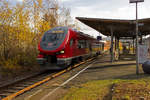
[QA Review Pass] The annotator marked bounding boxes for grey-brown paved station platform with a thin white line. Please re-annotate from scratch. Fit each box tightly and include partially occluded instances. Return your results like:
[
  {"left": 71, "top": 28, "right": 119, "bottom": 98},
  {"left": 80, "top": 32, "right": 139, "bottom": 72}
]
[{"left": 15, "top": 54, "right": 150, "bottom": 100}]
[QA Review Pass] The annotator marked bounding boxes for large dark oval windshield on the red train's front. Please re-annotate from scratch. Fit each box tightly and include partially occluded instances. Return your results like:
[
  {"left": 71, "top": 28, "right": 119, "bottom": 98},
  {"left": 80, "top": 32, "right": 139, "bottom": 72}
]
[{"left": 40, "top": 27, "right": 68, "bottom": 50}]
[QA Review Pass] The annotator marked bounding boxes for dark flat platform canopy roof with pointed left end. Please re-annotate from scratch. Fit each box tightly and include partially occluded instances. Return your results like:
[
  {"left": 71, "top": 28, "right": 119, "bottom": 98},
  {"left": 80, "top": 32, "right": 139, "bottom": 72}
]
[{"left": 76, "top": 17, "right": 150, "bottom": 38}]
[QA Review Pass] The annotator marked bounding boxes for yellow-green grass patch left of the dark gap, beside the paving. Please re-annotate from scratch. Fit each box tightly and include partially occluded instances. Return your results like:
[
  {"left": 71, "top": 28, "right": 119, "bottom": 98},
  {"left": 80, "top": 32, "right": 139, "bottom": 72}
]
[{"left": 61, "top": 81, "right": 111, "bottom": 100}]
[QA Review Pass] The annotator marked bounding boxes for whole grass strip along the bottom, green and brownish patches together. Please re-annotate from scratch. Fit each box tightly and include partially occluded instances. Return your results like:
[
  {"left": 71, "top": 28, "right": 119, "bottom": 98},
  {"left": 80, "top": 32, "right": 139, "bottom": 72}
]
[{"left": 60, "top": 79, "right": 150, "bottom": 100}]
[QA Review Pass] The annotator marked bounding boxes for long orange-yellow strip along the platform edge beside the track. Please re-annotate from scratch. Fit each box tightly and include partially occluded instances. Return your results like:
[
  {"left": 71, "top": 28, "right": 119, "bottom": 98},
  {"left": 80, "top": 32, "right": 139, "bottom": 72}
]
[{"left": 2, "top": 58, "right": 94, "bottom": 100}]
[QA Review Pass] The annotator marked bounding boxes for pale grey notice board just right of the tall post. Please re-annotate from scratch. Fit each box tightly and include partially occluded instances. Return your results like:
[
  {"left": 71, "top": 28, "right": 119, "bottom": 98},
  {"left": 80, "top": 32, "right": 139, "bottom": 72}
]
[{"left": 138, "top": 45, "right": 148, "bottom": 64}]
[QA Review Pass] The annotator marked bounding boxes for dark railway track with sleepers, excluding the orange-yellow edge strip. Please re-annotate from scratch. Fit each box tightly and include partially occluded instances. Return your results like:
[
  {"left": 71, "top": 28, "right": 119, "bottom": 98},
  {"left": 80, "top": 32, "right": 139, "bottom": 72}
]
[{"left": 0, "top": 71, "right": 56, "bottom": 100}]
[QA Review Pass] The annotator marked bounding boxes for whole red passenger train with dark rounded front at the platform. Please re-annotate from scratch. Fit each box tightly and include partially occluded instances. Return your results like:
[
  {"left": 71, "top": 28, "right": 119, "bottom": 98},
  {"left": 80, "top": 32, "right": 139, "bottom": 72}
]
[{"left": 37, "top": 27, "right": 104, "bottom": 69}]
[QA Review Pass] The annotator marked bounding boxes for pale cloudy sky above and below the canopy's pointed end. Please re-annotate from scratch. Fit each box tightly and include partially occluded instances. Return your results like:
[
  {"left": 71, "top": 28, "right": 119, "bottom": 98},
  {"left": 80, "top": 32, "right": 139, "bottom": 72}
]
[{"left": 13, "top": 0, "right": 150, "bottom": 37}]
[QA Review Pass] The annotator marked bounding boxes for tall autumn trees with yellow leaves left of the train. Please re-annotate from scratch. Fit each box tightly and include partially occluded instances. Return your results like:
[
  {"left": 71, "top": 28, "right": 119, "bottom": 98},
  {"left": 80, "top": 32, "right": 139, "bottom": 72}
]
[{"left": 0, "top": 0, "right": 75, "bottom": 69}]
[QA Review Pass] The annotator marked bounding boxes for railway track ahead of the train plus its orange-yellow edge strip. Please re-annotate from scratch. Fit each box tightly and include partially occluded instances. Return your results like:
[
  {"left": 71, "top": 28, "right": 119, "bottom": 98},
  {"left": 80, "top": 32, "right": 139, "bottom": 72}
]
[{"left": 0, "top": 58, "right": 94, "bottom": 100}]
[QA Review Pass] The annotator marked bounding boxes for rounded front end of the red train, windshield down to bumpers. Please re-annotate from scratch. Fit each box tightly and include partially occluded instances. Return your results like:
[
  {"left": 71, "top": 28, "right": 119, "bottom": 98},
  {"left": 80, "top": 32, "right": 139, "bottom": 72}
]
[{"left": 37, "top": 27, "right": 68, "bottom": 67}]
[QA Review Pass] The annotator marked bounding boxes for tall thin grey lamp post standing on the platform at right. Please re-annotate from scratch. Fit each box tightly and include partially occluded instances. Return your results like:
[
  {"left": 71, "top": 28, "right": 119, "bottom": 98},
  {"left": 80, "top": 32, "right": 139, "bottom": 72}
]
[{"left": 129, "top": 0, "right": 144, "bottom": 75}]
